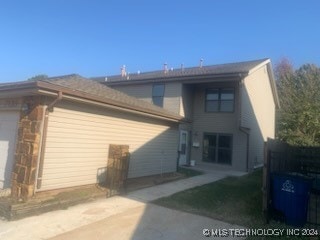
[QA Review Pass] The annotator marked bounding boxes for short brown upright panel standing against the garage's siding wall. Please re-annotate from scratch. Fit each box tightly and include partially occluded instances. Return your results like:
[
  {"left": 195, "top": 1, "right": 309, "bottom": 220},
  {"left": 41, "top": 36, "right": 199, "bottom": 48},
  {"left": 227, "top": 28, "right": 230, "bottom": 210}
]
[{"left": 106, "top": 144, "right": 130, "bottom": 197}]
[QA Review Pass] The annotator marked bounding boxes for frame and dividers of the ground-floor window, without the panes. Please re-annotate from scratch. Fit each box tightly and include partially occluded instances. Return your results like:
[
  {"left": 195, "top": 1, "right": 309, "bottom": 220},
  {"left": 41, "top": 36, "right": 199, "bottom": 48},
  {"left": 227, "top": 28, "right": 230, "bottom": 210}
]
[{"left": 202, "top": 132, "right": 233, "bottom": 166}]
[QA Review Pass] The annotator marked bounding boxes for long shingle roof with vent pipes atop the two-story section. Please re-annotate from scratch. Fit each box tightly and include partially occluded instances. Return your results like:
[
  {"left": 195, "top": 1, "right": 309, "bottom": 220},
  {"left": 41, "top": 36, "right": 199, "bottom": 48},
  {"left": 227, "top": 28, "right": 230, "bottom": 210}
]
[{"left": 92, "top": 58, "right": 268, "bottom": 82}]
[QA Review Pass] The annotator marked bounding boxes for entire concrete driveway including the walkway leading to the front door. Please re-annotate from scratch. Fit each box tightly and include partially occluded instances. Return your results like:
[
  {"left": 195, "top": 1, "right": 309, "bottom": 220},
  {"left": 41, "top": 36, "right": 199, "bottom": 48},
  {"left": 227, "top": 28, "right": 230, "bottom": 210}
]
[{"left": 0, "top": 167, "right": 243, "bottom": 240}]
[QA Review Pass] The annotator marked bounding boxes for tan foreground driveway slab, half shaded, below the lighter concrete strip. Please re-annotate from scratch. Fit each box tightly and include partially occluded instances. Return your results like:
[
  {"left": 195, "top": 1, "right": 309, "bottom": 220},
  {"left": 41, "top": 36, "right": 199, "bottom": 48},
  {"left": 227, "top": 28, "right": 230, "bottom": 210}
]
[{"left": 50, "top": 204, "right": 245, "bottom": 240}]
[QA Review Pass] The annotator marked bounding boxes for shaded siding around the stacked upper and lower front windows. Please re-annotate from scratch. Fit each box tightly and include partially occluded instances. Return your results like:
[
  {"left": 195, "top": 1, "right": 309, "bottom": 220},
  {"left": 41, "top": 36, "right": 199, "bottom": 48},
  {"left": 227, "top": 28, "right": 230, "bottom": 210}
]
[{"left": 191, "top": 83, "right": 246, "bottom": 171}]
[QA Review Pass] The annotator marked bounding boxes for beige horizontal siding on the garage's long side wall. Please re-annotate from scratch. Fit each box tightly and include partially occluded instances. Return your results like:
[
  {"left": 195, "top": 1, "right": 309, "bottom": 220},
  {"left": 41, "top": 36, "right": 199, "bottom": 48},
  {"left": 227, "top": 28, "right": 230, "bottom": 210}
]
[{"left": 40, "top": 102, "right": 178, "bottom": 190}]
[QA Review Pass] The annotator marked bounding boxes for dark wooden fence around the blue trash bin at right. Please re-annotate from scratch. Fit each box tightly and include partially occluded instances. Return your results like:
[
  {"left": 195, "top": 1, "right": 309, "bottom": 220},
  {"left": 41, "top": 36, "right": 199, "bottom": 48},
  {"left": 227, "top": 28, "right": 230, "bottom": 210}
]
[{"left": 263, "top": 139, "right": 320, "bottom": 225}]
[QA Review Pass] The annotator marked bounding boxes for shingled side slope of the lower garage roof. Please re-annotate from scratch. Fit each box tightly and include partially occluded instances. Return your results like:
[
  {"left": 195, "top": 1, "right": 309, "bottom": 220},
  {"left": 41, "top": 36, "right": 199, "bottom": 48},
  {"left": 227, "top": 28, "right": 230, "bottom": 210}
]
[{"left": 40, "top": 74, "right": 183, "bottom": 119}]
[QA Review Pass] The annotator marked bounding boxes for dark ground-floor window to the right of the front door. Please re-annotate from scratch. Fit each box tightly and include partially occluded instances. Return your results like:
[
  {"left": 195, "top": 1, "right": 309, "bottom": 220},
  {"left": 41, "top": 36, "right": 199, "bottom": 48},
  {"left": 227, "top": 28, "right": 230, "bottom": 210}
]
[{"left": 203, "top": 133, "right": 232, "bottom": 164}]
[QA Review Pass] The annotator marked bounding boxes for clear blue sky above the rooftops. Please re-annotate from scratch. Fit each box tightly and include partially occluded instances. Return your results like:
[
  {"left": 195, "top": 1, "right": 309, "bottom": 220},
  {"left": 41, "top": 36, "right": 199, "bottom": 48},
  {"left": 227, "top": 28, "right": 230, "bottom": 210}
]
[{"left": 0, "top": 0, "right": 320, "bottom": 82}]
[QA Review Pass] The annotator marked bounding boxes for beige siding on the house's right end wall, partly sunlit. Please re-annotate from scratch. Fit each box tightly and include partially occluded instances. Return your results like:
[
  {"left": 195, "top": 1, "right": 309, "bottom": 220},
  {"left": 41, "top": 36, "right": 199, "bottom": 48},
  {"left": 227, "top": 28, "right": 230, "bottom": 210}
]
[{"left": 241, "top": 66, "right": 275, "bottom": 167}]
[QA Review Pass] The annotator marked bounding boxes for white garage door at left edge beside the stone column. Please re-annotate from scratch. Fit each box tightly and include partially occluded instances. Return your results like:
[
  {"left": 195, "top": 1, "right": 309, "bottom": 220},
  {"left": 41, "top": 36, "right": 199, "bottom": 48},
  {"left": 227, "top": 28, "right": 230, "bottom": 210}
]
[{"left": 0, "top": 110, "right": 19, "bottom": 189}]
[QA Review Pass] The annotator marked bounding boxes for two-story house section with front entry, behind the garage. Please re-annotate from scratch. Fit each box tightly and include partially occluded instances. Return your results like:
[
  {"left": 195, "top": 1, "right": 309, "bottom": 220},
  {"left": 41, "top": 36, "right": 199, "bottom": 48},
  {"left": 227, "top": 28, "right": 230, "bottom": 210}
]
[{"left": 92, "top": 59, "right": 279, "bottom": 171}]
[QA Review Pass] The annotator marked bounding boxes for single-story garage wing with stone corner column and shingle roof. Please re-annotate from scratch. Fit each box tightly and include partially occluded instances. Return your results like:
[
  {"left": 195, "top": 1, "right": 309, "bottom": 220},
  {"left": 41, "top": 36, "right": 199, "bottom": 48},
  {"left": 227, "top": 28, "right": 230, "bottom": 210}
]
[{"left": 0, "top": 75, "right": 183, "bottom": 200}]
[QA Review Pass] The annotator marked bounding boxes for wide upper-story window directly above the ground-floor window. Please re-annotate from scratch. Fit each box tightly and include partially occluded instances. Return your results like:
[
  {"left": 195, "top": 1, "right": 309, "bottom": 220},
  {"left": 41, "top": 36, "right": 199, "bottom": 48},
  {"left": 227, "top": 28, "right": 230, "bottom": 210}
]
[{"left": 206, "top": 88, "right": 234, "bottom": 112}]
